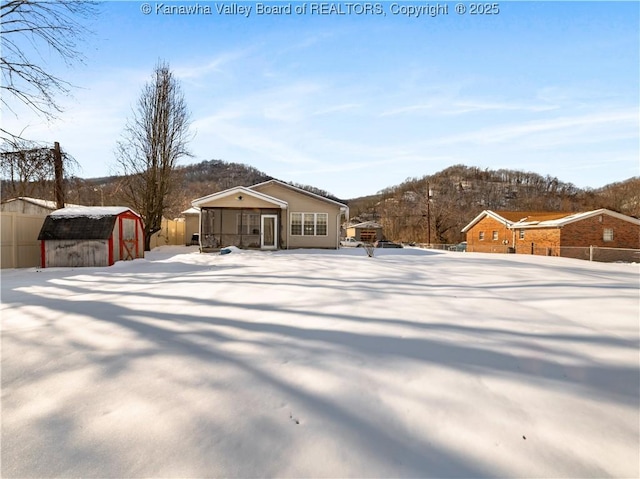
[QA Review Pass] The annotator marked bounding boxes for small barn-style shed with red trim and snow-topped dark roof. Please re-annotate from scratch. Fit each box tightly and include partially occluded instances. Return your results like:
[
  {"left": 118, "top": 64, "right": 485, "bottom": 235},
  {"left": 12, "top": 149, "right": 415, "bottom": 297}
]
[{"left": 38, "top": 206, "right": 144, "bottom": 268}]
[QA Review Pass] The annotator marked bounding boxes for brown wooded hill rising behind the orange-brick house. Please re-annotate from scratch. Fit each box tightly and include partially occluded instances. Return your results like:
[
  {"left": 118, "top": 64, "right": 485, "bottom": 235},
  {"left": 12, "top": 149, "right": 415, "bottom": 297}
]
[{"left": 349, "top": 165, "right": 640, "bottom": 243}]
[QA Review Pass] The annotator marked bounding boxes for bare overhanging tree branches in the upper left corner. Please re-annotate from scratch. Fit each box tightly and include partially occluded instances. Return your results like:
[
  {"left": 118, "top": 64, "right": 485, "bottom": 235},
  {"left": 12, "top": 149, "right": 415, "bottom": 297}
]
[{"left": 0, "top": 0, "right": 97, "bottom": 138}]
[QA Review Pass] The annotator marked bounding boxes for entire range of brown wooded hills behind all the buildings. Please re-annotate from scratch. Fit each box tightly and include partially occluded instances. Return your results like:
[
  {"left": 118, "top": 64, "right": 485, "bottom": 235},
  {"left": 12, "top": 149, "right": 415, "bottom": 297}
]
[{"left": 2, "top": 160, "right": 640, "bottom": 243}]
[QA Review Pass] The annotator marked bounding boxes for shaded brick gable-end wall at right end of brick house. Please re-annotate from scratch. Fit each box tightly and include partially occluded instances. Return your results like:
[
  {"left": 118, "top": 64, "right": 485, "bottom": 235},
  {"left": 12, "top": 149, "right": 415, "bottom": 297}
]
[{"left": 561, "top": 214, "right": 640, "bottom": 249}]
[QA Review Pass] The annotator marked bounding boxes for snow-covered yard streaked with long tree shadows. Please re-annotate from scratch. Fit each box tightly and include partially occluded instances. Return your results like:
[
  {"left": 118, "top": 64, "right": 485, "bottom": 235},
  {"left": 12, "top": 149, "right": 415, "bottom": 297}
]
[{"left": 1, "top": 247, "right": 640, "bottom": 478}]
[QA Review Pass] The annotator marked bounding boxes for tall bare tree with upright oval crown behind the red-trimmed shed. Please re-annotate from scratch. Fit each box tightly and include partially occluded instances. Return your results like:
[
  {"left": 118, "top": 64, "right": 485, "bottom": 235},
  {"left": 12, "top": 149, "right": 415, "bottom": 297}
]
[{"left": 116, "top": 63, "right": 190, "bottom": 251}]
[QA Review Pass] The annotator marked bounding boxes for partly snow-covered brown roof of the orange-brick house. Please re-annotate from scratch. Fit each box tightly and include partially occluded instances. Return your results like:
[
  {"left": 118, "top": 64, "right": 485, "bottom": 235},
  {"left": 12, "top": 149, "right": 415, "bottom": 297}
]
[{"left": 462, "top": 208, "right": 640, "bottom": 233}]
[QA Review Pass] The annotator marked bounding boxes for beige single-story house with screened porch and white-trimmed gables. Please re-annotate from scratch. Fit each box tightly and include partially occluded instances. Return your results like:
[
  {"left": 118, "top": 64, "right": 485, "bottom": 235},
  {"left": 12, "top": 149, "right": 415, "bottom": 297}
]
[{"left": 191, "top": 180, "right": 349, "bottom": 252}]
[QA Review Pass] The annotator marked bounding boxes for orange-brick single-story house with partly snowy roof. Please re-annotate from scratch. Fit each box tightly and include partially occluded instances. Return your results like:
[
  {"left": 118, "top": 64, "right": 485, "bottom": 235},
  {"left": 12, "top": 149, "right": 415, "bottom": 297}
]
[{"left": 462, "top": 209, "right": 640, "bottom": 257}]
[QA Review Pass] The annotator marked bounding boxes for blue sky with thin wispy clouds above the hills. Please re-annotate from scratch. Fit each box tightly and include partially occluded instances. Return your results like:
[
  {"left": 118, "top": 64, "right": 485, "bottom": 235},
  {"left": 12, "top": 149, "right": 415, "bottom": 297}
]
[{"left": 3, "top": 1, "right": 640, "bottom": 198}]
